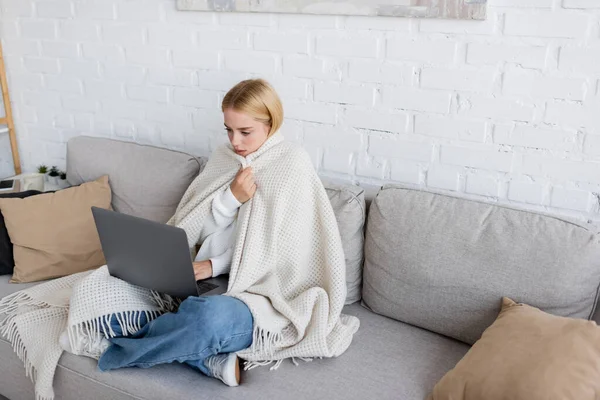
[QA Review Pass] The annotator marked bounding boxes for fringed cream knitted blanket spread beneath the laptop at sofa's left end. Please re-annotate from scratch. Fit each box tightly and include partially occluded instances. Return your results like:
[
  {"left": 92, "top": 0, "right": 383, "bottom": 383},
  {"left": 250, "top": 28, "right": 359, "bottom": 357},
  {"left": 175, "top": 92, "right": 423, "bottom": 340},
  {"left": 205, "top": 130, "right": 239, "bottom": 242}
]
[{"left": 0, "top": 266, "right": 175, "bottom": 400}]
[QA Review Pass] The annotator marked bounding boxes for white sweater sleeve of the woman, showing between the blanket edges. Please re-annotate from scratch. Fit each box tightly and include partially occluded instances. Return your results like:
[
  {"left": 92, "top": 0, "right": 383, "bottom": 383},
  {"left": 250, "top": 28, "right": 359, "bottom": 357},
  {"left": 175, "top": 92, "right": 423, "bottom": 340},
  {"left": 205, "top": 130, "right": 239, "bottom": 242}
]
[{"left": 195, "top": 187, "right": 242, "bottom": 278}]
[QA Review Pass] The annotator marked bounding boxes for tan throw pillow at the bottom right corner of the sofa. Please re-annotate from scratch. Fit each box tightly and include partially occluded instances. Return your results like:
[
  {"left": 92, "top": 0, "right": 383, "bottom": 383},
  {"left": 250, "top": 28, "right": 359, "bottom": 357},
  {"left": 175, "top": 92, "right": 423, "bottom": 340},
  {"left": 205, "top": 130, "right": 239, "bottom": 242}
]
[{"left": 429, "top": 298, "right": 600, "bottom": 400}]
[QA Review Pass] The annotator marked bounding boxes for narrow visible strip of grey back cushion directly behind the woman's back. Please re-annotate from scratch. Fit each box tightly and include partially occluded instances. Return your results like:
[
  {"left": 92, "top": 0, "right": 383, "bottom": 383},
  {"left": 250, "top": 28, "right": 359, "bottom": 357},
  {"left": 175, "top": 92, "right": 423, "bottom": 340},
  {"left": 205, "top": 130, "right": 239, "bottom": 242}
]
[{"left": 323, "top": 180, "right": 366, "bottom": 304}]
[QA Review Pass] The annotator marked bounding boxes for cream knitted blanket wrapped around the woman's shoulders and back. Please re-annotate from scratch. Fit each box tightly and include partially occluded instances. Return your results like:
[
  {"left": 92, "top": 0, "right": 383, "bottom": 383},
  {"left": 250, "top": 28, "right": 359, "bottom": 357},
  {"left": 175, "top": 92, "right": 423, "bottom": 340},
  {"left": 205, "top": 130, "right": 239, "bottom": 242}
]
[{"left": 168, "top": 133, "right": 359, "bottom": 368}]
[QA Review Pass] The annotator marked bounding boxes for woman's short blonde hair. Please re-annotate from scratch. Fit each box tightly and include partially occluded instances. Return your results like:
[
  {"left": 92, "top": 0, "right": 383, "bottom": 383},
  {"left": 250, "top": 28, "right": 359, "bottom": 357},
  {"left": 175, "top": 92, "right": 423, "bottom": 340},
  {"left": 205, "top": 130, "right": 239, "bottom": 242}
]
[{"left": 221, "top": 79, "right": 283, "bottom": 136}]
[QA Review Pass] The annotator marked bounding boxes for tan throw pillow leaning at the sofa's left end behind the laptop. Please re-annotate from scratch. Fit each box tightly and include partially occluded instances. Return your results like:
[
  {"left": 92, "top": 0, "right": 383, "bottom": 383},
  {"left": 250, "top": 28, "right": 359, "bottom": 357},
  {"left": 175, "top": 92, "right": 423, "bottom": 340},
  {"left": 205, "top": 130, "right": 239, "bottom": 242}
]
[{"left": 0, "top": 176, "right": 111, "bottom": 283}]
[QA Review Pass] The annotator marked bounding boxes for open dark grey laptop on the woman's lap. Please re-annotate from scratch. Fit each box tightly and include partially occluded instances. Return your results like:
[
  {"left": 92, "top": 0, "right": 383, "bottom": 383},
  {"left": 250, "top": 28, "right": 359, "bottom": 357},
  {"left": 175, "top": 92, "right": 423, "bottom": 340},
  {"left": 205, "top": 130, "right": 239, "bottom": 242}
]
[{"left": 92, "top": 207, "right": 228, "bottom": 299}]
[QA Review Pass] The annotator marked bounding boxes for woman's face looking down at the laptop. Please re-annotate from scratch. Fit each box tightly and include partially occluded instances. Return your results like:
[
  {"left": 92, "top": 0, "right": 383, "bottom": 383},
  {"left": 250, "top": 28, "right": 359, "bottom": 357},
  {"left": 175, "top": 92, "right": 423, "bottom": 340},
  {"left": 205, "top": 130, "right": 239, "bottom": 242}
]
[{"left": 223, "top": 108, "right": 270, "bottom": 157}]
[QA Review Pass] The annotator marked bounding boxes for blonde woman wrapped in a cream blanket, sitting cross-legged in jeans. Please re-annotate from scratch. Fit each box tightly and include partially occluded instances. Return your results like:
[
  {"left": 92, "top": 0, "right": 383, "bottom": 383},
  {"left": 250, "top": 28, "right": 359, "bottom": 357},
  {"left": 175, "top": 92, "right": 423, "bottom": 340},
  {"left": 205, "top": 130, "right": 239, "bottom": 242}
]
[{"left": 99, "top": 80, "right": 358, "bottom": 386}]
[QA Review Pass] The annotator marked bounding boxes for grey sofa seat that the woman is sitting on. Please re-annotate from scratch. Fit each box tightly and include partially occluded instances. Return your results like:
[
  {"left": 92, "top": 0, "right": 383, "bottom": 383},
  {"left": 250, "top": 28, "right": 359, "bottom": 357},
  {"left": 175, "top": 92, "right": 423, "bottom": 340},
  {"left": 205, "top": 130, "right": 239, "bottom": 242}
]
[{"left": 0, "top": 277, "right": 469, "bottom": 400}]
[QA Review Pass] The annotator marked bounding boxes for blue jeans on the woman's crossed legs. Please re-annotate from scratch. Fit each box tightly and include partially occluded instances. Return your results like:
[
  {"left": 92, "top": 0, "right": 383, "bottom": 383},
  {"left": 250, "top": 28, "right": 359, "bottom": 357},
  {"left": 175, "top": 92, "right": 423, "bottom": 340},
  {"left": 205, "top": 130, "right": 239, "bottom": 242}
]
[{"left": 98, "top": 296, "right": 253, "bottom": 376}]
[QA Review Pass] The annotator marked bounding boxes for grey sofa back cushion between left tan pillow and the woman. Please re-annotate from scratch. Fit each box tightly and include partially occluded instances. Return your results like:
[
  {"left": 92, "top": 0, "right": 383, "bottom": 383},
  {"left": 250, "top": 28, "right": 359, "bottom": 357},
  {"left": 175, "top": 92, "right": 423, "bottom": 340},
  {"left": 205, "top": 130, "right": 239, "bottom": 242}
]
[{"left": 67, "top": 136, "right": 204, "bottom": 222}]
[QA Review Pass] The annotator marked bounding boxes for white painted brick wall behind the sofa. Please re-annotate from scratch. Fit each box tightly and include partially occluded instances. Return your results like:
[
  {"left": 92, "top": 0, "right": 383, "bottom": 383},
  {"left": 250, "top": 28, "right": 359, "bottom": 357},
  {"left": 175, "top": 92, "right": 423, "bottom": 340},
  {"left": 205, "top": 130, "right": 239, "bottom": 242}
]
[{"left": 0, "top": 0, "right": 600, "bottom": 221}]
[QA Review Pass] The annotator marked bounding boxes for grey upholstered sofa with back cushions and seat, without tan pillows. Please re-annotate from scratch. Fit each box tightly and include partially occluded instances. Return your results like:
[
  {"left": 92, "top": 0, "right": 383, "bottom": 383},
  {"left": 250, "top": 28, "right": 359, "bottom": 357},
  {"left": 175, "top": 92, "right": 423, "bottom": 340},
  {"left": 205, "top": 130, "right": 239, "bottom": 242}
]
[{"left": 0, "top": 137, "right": 600, "bottom": 400}]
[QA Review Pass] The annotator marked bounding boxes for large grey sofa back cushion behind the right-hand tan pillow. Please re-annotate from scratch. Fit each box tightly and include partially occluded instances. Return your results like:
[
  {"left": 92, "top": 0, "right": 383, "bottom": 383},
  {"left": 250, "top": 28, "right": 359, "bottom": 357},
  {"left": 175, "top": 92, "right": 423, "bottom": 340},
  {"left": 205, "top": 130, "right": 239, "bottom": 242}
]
[{"left": 363, "top": 185, "right": 600, "bottom": 344}]
